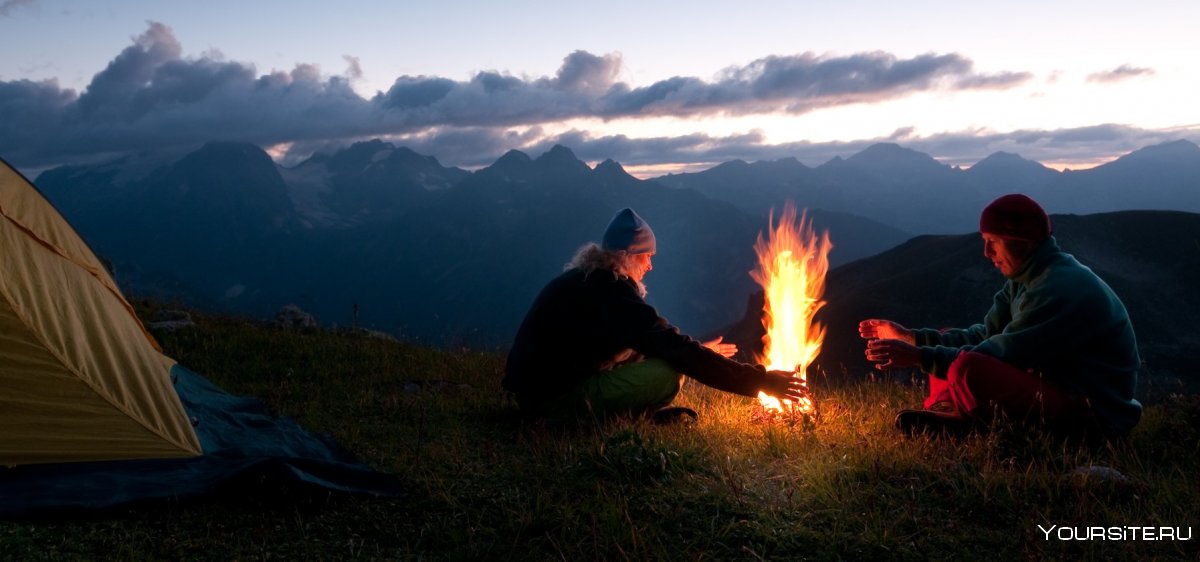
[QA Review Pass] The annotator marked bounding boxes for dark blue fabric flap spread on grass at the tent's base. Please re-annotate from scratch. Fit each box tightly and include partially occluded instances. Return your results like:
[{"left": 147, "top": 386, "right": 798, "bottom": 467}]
[{"left": 0, "top": 365, "right": 404, "bottom": 519}]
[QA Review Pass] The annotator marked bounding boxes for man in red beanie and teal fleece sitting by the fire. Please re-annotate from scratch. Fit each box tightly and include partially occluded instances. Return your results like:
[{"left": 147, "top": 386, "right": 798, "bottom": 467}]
[{"left": 858, "top": 193, "right": 1141, "bottom": 438}]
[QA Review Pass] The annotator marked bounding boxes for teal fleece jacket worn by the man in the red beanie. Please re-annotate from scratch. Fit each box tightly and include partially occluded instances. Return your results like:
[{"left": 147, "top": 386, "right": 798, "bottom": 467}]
[{"left": 913, "top": 237, "right": 1141, "bottom": 435}]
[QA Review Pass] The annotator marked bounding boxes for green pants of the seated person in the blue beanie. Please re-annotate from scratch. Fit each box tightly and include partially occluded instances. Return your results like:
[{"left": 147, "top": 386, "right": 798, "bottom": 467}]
[{"left": 517, "top": 359, "right": 683, "bottom": 418}]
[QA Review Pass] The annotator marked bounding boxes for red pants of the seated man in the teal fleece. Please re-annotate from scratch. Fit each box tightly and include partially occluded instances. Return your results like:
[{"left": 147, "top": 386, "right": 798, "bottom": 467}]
[{"left": 925, "top": 352, "right": 1097, "bottom": 432}]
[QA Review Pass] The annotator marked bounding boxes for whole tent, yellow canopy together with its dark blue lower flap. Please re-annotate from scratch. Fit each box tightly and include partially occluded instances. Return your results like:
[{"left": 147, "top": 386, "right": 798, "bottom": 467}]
[{"left": 0, "top": 160, "right": 400, "bottom": 516}]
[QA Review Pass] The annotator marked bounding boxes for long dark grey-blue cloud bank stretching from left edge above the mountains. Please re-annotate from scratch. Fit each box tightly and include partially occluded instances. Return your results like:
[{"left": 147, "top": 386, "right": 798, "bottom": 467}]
[{"left": 0, "top": 20, "right": 1025, "bottom": 166}]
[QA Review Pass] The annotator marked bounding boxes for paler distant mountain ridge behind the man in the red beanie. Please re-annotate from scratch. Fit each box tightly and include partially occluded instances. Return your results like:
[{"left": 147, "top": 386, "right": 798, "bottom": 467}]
[{"left": 655, "top": 141, "right": 1200, "bottom": 234}]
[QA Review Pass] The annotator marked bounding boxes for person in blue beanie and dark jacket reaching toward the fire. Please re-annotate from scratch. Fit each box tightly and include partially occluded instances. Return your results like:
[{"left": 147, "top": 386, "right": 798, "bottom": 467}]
[{"left": 503, "top": 208, "right": 805, "bottom": 420}]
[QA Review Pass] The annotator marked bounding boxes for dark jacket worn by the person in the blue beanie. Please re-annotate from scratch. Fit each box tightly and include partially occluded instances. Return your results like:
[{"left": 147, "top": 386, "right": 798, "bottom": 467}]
[{"left": 503, "top": 269, "right": 767, "bottom": 399}]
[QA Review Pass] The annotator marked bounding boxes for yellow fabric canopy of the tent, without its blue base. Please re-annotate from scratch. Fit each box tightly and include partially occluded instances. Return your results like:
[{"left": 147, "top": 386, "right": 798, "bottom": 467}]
[{"left": 0, "top": 161, "right": 202, "bottom": 466}]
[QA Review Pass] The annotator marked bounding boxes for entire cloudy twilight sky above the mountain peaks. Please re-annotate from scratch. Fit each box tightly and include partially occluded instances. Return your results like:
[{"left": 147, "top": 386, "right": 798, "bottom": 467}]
[{"left": 0, "top": 0, "right": 1200, "bottom": 175}]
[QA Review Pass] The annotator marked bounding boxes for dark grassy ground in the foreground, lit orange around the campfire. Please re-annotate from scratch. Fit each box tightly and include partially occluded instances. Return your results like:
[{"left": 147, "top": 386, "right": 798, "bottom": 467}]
[{"left": 0, "top": 307, "right": 1200, "bottom": 561}]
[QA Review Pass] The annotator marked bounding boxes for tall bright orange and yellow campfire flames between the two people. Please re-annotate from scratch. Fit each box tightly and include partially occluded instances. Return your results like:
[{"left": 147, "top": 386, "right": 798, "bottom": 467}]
[{"left": 750, "top": 202, "right": 833, "bottom": 413}]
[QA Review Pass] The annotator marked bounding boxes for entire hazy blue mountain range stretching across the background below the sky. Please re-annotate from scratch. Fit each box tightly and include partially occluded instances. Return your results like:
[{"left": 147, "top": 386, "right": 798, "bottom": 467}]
[{"left": 28, "top": 141, "right": 1200, "bottom": 346}]
